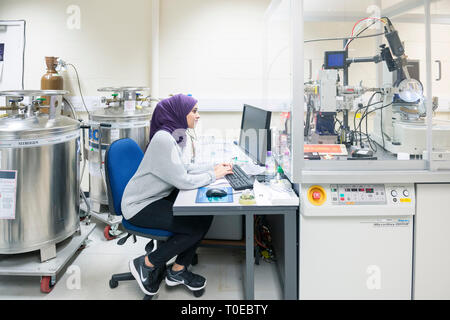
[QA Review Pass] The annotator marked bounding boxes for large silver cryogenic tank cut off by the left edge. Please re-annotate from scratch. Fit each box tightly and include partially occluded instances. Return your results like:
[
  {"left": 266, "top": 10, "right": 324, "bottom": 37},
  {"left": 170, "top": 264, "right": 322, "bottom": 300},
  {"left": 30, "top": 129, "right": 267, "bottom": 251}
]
[{"left": 0, "top": 90, "right": 80, "bottom": 260}]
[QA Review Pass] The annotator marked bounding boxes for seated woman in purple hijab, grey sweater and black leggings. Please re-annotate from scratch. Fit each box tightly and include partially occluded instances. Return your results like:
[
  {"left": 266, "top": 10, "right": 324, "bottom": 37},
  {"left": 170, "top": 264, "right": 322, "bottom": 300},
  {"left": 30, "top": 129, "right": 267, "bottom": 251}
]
[{"left": 122, "top": 94, "right": 232, "bottom": 295}]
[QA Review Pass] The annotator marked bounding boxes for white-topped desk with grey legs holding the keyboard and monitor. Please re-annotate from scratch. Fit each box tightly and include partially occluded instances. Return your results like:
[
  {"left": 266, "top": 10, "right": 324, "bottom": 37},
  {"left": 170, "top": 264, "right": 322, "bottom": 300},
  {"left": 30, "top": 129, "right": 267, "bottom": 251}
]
[{"left": 173, "top": 190, "right": 298, "bottom": 300}]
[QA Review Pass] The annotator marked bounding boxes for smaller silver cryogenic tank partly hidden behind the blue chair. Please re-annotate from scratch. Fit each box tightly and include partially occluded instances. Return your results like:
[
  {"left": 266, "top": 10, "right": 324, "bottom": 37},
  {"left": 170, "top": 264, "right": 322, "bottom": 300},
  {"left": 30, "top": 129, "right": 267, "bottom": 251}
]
[{"left": 89, "top": 87, "right": 152, "bottom": 213}]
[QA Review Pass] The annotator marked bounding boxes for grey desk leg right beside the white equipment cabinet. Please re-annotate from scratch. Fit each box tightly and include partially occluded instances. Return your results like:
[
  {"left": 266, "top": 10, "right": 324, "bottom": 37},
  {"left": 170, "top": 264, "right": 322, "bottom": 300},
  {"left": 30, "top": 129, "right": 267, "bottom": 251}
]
[{"left": 284, "top": 213, "right": 297, "bottom": 300}]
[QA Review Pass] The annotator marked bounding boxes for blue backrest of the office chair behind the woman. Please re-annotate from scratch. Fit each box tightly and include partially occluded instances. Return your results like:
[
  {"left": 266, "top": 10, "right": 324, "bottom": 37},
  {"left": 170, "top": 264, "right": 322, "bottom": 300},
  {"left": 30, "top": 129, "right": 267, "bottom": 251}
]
[{"left": 105, "top": 138, "right": 144, "bottom": 216}]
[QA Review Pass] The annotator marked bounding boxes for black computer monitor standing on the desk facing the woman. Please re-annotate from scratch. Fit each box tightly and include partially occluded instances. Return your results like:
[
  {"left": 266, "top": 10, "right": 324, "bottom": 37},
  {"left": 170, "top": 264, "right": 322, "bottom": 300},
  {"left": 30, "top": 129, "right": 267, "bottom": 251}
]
[{"left": 239, "top": 104, "right": 272, "bottom": 165}]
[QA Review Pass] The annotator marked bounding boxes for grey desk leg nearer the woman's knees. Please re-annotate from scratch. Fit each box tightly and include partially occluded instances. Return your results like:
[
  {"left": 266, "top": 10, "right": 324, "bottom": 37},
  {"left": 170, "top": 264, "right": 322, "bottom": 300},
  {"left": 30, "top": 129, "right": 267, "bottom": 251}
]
[{"left": 244, "top": 214, "right": 255, "bottom": 300}]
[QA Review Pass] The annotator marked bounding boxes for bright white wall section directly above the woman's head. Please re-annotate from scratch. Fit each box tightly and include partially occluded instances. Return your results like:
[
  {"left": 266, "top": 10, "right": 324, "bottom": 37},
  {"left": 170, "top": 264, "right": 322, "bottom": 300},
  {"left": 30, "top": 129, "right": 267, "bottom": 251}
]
[{"left": 160, "top": 0, "right": 270, "bottom": 100}]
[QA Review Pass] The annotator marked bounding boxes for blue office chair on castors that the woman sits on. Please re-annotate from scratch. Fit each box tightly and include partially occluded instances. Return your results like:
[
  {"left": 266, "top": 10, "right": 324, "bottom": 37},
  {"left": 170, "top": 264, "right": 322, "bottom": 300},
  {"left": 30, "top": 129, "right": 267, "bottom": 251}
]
[{"left": 105, "top": 138, "right": 198, "bottom": 300}]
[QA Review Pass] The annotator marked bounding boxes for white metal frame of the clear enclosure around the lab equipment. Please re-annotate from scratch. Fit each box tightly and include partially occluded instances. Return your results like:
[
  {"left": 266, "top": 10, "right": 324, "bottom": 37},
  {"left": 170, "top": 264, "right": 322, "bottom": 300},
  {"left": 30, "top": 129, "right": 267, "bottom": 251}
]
[{"left": 263, "top": 0, "right": 450, "bottom": 183}]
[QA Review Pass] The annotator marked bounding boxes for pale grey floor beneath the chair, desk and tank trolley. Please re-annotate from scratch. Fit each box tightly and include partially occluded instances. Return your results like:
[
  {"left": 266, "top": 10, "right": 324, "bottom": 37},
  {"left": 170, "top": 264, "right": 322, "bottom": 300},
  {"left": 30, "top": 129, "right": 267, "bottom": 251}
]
[{"left": 0, "top": 220, "right": 281, "bottom": 300}]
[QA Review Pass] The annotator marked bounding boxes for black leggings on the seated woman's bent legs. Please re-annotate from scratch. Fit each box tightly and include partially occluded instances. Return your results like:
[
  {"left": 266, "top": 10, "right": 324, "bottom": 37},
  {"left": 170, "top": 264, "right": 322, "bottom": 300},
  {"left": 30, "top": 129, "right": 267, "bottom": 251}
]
[{"left": 128, "top": 189, "right": 213, "bottom": 267}]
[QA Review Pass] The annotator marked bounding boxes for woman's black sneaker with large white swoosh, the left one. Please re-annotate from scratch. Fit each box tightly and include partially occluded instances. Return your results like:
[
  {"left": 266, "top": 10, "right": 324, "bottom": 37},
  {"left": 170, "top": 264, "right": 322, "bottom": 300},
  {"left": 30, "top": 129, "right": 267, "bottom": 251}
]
[{"left": 129, "top": 255, "right": 166, "bottom": 296}]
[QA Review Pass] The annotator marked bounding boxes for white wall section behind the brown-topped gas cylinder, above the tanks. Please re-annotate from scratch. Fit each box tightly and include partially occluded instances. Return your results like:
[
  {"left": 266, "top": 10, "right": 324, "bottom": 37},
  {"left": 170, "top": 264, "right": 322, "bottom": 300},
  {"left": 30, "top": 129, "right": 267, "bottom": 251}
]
[{"left": 0, "top": 0, "right": 151, "bottom": 96}]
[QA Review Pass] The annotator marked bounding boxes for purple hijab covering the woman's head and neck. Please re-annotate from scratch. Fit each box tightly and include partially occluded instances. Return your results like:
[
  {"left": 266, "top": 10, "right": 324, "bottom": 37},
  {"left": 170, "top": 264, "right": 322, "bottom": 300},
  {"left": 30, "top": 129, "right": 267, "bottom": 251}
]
[{"left": 150, "top": 94, "right": 197, "bottom": 146}]
